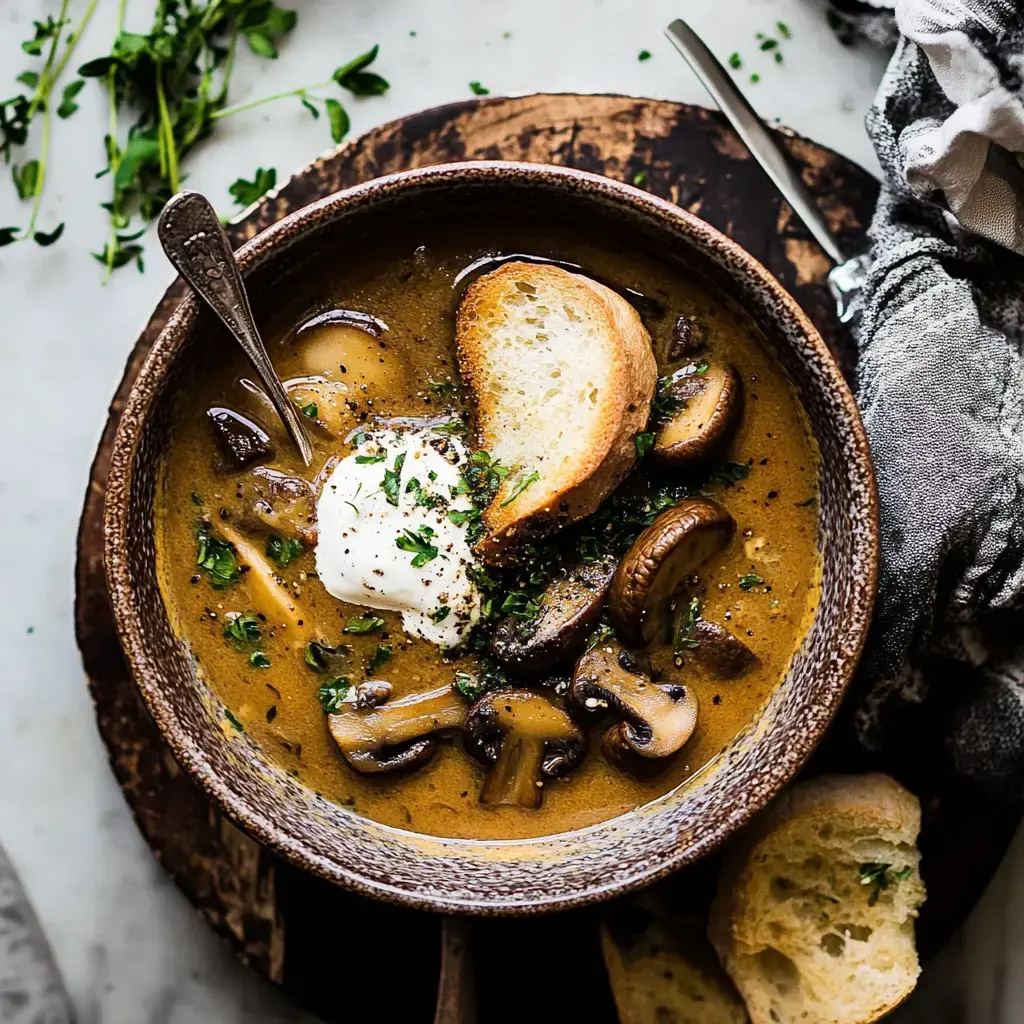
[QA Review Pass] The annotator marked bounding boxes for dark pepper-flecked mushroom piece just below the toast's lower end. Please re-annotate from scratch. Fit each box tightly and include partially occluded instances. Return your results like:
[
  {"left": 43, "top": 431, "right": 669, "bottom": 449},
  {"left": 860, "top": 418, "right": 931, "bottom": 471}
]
[{"left": 490, "top": 558, "right": 615, "bottom": 672}]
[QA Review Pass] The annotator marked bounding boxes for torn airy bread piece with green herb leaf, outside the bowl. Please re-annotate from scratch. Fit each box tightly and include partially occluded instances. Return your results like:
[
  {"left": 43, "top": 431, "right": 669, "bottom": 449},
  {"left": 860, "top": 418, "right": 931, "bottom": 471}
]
[{"left": 709, "top": 774, "right": 925, "bottom": 1024}]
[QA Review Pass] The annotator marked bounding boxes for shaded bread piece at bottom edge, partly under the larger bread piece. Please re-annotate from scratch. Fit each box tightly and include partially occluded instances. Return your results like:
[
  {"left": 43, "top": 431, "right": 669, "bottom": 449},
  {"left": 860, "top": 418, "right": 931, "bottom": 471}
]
[{"left": 601, "top": 920, "right": 748, "bottom": 1024}]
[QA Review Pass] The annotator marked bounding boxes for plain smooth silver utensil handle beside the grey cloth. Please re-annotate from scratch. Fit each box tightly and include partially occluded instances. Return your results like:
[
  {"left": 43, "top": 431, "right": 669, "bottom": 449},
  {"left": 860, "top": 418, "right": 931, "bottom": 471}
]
[{"left": 665, "top": 18, "right": 869, "bottom": 324}]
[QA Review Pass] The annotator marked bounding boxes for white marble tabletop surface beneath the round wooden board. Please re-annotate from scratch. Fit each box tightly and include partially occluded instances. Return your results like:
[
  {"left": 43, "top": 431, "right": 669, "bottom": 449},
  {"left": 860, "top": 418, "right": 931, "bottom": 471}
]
[{"left": 0, "top": 0, "right": 1024, "bottom": 1024}]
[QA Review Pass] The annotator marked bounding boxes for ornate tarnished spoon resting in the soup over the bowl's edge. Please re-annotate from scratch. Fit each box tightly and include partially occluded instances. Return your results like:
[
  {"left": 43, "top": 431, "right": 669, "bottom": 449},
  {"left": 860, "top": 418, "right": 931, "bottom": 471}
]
[{"left": 157, "top": 191, "right": 313, "bottom": 466}]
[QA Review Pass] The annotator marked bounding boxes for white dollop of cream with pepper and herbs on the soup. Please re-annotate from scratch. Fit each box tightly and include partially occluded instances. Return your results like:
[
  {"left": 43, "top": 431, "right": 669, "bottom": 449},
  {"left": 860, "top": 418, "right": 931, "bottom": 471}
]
[{"left": 316, "top": 429, "right": 480, "bottom": 647}]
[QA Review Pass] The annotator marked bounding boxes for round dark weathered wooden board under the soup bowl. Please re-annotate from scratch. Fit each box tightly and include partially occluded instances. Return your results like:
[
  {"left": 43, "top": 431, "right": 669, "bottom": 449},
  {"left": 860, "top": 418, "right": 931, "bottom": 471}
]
[{"left": 75, "top": 95, "right": 1020, "bottom": 1024}]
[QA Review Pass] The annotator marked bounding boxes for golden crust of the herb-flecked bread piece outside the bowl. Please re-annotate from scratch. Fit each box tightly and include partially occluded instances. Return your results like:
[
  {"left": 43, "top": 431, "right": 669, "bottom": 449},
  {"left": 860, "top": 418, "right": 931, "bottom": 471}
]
[{"left": 708, "top": 772, "right": 921, "bottom": 1024}]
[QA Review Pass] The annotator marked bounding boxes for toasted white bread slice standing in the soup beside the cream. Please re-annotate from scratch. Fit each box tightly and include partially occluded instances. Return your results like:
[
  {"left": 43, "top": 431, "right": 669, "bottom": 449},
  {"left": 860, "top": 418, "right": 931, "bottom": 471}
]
[{"left": 456, "top": 262, "right": 657, "bottom": 563}]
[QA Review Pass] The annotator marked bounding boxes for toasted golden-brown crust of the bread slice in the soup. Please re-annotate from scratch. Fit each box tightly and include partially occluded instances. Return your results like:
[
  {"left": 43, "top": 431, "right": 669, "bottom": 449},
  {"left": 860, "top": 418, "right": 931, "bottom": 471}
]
[{"left": 456, "top": 261, "right": 657, "bottom": 564}]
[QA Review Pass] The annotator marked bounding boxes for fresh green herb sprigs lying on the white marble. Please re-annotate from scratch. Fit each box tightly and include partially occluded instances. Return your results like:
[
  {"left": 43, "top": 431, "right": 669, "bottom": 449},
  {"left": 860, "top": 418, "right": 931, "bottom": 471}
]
[{"left": 0, "top": 0, "right": 388, "bottom": 280}]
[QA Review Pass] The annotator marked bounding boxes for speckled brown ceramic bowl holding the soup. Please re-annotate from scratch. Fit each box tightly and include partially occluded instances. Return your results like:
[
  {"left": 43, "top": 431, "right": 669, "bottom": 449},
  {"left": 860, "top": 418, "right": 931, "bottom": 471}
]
[{"left": 105, "top": 162, "right": 879, "bottom": 913}]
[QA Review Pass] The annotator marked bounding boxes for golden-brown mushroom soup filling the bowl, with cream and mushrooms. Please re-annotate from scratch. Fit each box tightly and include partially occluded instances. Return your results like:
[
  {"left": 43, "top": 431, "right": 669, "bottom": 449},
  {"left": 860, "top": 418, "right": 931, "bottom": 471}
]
[{"left": 157, "top": 216, "right": 819, "bottom": 839}]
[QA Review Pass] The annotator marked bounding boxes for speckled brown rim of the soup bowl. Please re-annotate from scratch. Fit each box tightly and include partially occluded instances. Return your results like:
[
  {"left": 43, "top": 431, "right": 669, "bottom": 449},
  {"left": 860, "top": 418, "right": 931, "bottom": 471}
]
[{"left": 103, "top": 160, "right": 881, "bottom": 914}]
